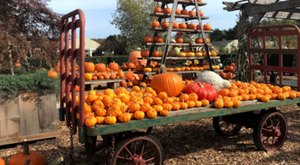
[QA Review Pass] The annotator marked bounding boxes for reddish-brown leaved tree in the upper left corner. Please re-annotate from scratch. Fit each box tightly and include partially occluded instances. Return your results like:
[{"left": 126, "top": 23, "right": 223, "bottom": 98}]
[{"left": 0, "top": 0, "right": 59, "bottom": 71}]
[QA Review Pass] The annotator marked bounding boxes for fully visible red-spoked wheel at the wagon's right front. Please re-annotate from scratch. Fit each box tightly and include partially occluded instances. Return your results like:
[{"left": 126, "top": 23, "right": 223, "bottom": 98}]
[{"left": 253, "top": 111, "right": 287, "bottom": 151}]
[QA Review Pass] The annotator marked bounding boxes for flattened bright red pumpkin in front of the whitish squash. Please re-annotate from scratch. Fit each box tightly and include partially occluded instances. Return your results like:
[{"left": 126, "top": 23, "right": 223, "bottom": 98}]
[{"left": 184, "top": 82, "right": 217, "bottom": 101}]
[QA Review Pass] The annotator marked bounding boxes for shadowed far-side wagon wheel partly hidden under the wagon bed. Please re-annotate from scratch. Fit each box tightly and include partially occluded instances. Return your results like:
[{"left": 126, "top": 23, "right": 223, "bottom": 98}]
[{"left": 213, "top": 117, "right": 242, "bottom": 136}]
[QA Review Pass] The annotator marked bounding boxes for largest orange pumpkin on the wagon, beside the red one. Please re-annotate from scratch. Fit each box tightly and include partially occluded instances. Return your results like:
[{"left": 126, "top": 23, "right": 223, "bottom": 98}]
[{"left": 150, "top": 73, "right": 184, "bottom": 97}]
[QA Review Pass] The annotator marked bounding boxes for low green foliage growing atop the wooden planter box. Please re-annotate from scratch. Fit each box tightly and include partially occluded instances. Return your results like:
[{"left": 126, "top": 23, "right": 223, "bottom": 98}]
[{"left": 0, "top": 70, "right": 59, "bottom": 97}]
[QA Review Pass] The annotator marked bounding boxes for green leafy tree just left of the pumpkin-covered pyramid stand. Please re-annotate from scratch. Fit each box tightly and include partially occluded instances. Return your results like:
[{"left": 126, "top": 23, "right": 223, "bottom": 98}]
[{"left": 111, "top": 0, "right": 154, "bottom": 51}]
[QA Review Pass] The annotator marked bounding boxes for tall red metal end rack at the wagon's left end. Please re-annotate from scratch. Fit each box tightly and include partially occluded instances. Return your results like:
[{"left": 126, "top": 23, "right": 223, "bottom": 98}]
[{"left": 60, "top": 9, "right": 85, "bottom": 134}]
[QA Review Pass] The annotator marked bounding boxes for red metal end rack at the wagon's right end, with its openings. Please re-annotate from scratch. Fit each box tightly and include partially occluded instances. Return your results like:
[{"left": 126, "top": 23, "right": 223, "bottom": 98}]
[{"left": 248, "top": 25, "right": 300, "bottom": 89}]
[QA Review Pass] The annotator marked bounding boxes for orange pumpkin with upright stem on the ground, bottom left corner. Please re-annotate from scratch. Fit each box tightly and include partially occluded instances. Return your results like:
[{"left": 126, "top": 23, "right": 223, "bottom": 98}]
[{"left": 8, "top": 142, "right": 46, "bottom": 165}]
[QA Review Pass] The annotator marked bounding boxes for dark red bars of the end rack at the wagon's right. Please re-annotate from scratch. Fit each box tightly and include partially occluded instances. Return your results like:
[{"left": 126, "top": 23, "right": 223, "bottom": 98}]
[{"left": 248, "top": 25, "right": 300, "bottom": 89}]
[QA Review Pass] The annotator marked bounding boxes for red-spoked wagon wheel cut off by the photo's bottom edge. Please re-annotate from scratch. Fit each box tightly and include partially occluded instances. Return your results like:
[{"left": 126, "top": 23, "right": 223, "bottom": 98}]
[{"left": 112, "top": 135, "right": 163, "bottom": 165}]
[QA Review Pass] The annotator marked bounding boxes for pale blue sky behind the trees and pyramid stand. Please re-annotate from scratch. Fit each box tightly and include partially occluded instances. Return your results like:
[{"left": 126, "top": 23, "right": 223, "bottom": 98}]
[{"left": 48, "top": 0, "right": 238, "bottom": 38}]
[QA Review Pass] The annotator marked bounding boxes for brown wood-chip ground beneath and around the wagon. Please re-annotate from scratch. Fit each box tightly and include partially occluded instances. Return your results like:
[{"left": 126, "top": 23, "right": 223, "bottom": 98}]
[{"left": 0, "top": 106, "right": 300, "bottom": 165}]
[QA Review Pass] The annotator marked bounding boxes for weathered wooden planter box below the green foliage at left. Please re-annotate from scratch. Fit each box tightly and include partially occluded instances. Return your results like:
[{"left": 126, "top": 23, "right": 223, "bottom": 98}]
[{"left": 0, "top": 92, "right": 58, "bottom": 145}]
